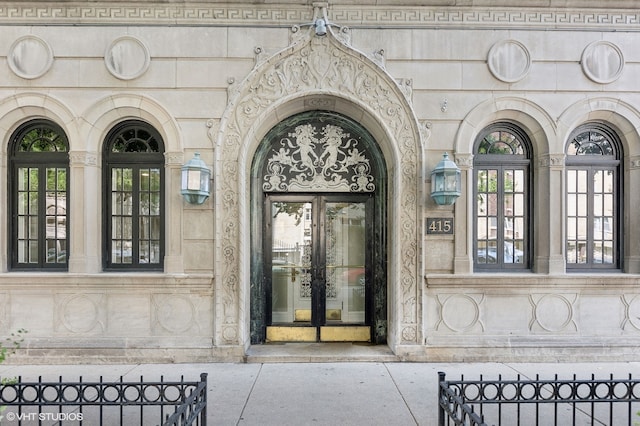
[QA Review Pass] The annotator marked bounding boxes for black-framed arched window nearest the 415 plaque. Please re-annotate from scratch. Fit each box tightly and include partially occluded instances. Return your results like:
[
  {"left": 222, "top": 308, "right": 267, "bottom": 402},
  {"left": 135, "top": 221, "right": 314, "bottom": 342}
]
[{"left": 474, "top": 123, "right": 531, "bottom": 271}]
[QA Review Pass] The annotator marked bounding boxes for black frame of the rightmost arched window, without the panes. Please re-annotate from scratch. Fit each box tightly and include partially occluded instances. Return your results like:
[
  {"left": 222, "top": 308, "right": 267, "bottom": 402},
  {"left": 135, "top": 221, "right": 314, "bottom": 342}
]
[{"left": 564, "top": 122, "right": 624, "bottom": 273}]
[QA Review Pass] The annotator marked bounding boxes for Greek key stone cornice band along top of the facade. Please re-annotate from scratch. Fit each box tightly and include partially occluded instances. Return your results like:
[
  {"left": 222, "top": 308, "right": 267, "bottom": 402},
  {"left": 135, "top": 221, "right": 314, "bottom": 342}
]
[{"left": 0, "top": 1, "right": 640, "bottom": 31}]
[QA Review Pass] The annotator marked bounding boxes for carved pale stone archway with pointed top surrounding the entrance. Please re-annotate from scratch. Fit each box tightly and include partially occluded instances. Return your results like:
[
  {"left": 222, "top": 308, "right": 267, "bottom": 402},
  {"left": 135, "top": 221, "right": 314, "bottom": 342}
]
[{"left": 214, "top": 9, "right": 423, "bottom": 348}]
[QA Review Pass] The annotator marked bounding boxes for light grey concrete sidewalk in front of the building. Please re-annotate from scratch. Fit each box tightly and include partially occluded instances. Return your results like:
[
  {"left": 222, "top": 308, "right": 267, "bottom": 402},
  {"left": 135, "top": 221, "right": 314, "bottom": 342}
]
[{"left": 0, "top": 354, "right": 640, "bottom": 426}]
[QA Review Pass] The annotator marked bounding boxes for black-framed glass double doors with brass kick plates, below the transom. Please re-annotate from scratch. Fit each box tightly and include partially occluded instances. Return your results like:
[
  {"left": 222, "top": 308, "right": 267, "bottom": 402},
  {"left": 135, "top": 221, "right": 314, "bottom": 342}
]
[{"left": 263, "top": 194, "right": 374, "bottom": 341}]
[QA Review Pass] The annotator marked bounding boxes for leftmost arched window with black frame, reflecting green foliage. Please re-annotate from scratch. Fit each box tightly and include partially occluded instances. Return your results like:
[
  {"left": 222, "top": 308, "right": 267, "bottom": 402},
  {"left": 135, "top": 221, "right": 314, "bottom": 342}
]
[{"left": 9, "top": 120, "right": 69, "bottom": 270}]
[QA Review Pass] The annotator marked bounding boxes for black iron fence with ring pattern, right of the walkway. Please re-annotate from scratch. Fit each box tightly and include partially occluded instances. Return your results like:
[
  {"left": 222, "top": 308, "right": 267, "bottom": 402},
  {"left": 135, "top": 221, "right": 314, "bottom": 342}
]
[{"left": 438, "top": 372, "right": 640, "bottom": 426}]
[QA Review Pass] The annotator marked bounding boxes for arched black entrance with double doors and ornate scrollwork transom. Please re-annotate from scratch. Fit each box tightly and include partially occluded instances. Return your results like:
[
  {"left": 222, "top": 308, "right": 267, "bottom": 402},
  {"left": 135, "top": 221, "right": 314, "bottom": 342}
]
[{"left": 251, "top": 111, "right": 387, "bottom": 343}]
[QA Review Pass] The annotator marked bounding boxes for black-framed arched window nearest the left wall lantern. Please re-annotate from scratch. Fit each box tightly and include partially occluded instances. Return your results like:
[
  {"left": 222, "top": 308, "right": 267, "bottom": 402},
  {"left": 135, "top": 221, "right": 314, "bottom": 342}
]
[{"left": 103, "top": 121, "right": 164, "bottom": 270}]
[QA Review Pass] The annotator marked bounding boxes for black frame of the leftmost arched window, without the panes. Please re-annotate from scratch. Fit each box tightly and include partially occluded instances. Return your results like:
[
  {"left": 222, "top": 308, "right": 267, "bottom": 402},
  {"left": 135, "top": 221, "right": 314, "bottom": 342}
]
[{"left": 8, "top": 119, "right": 70, "bottom": 272}]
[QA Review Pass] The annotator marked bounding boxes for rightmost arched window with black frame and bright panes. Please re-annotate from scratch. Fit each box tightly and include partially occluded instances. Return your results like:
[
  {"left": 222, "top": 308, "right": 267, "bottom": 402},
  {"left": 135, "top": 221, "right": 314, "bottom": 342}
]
[{"left": 566, "top": 123, "right": 621, "bottom": 270}]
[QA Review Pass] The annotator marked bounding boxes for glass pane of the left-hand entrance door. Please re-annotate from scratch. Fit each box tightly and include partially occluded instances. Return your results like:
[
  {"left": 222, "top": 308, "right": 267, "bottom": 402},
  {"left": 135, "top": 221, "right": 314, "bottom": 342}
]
[{"left": 271, "top": 201, "right": 313, "bottom": 323}]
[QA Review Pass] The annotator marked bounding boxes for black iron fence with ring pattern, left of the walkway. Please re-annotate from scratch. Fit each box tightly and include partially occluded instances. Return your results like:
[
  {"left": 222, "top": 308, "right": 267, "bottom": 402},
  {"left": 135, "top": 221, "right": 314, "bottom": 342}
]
[{"left": 0, "top": 373, "right": 207, "bottom": 426}]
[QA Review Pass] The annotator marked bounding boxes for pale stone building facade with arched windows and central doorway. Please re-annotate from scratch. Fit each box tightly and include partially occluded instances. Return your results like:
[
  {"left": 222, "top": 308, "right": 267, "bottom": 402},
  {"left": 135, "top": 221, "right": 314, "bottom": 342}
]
[{"left": 0, "top": 0, "right": 640, "bottom": 362}]
